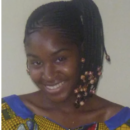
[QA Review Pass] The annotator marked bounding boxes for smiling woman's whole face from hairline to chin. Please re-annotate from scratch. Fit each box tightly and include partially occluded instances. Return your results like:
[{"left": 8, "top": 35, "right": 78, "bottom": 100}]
[{"left": 25, "top": 29, "right": 80, "bottom": 102}]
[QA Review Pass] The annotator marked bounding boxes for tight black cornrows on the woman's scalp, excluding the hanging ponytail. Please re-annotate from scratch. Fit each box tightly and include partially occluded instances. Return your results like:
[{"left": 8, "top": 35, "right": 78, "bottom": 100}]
[{"left": 24, "top": 1, "right": 83, "bottom": 45}]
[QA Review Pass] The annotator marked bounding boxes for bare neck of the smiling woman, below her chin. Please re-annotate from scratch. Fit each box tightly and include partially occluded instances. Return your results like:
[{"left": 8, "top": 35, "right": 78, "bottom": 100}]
[{"left": 38, "top": 91, "right": 96, "bottom": 112}]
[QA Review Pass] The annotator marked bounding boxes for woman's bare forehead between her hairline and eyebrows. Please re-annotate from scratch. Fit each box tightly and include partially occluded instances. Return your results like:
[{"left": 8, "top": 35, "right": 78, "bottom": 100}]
[{"left": 25, "top": 28, "right": 77, "bottom": 52}]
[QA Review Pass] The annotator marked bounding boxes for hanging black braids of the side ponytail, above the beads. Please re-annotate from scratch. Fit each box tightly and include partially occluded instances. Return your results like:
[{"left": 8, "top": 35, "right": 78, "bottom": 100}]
[{"left": 73, "top": 0, "right": 104, "bottom": 71}]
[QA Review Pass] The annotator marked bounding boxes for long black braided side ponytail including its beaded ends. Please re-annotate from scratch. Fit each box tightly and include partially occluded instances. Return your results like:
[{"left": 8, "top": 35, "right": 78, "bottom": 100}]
[{"left": 73, "top": 0, "right": 110, "bottom": 107}]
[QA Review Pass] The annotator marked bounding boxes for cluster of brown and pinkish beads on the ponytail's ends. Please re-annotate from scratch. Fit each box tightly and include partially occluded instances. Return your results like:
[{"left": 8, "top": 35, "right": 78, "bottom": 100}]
[{"left": 74, "top": 58, "right": 102, "bottom": 108}]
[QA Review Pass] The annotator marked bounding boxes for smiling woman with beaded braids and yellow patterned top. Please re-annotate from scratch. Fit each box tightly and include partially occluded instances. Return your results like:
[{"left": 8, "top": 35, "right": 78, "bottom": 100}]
[{"left": 2, "top": 0, "right": 130, "bottom": 130}]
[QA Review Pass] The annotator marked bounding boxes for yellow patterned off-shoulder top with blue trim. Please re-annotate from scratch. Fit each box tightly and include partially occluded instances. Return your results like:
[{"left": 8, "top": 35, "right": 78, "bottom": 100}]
[{"left": 2, "top": 95, "right": 130, "bottom": 130}]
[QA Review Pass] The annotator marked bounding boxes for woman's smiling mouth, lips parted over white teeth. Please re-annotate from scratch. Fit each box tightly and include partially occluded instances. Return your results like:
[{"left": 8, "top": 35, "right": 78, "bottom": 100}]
[{"left": 45, "top": 82, "right": 64, "bottom": 94}]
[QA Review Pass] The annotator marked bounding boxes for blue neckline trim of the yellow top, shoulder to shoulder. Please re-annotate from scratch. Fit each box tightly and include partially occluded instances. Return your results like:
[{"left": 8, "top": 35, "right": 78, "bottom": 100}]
[{"left": 3, "top": 95, "right": 130, "bottom": 130}]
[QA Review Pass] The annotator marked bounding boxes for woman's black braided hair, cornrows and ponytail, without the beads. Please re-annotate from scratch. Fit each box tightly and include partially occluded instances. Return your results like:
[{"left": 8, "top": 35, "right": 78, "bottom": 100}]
[{"left": 24, "top": 0, "right": 108, "bottom": 96}]
